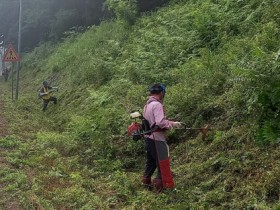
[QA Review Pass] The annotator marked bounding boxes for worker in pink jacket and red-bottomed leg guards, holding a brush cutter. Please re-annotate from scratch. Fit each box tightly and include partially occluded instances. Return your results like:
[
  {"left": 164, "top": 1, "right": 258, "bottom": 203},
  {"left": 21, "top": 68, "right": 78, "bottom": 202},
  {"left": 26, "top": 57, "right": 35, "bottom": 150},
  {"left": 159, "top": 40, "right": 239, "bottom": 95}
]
[{"left": 142, "top": 84, "right": 182, "bottom": 193}]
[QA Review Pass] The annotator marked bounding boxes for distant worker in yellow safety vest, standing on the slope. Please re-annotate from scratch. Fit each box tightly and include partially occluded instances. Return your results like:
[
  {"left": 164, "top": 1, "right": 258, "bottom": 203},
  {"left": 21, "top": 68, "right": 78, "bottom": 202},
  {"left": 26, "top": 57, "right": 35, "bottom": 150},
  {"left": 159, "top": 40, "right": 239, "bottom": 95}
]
[{"left": 39, "top": 81, "right": 58, "bottom": 111}]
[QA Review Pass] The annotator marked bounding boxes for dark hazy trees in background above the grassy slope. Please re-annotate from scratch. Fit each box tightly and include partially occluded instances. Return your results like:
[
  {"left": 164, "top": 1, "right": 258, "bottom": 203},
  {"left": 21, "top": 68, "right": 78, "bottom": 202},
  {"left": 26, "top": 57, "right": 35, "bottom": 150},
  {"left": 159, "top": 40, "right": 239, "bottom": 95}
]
[{"left": 0, "top": 0, "right": 168, "bottom": 51}]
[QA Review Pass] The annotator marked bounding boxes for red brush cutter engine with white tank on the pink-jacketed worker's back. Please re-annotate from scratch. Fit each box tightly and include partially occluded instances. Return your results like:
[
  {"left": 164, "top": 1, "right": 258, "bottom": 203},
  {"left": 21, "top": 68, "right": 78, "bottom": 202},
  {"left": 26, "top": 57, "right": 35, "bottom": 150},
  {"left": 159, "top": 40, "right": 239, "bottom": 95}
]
[{"left": 127, "top": 112, "right": 153, "bottom": 141}]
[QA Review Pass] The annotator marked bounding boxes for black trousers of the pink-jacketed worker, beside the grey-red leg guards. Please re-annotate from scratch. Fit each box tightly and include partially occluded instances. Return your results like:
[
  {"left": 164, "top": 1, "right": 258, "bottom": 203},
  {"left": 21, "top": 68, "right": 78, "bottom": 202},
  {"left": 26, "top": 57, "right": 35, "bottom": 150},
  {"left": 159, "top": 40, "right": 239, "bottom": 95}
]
[{"left": 144, "top": 138, "right": 161, "bottom": 179}]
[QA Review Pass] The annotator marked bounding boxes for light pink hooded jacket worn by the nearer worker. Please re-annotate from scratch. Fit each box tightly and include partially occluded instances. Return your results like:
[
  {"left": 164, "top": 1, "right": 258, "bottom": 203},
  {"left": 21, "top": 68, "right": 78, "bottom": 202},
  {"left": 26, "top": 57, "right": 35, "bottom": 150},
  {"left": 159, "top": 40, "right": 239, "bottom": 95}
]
[{"left": 144, "top": 96, "right": 174, "bottom": 141}]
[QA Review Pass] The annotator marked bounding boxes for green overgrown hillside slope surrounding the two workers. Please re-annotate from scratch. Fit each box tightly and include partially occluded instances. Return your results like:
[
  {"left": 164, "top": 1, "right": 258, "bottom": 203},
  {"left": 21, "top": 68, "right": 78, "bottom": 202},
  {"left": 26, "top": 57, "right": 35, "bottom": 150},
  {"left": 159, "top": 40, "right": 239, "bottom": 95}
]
[{"left": 1, "top": 0, "right": 280, "bottom": 209}]
